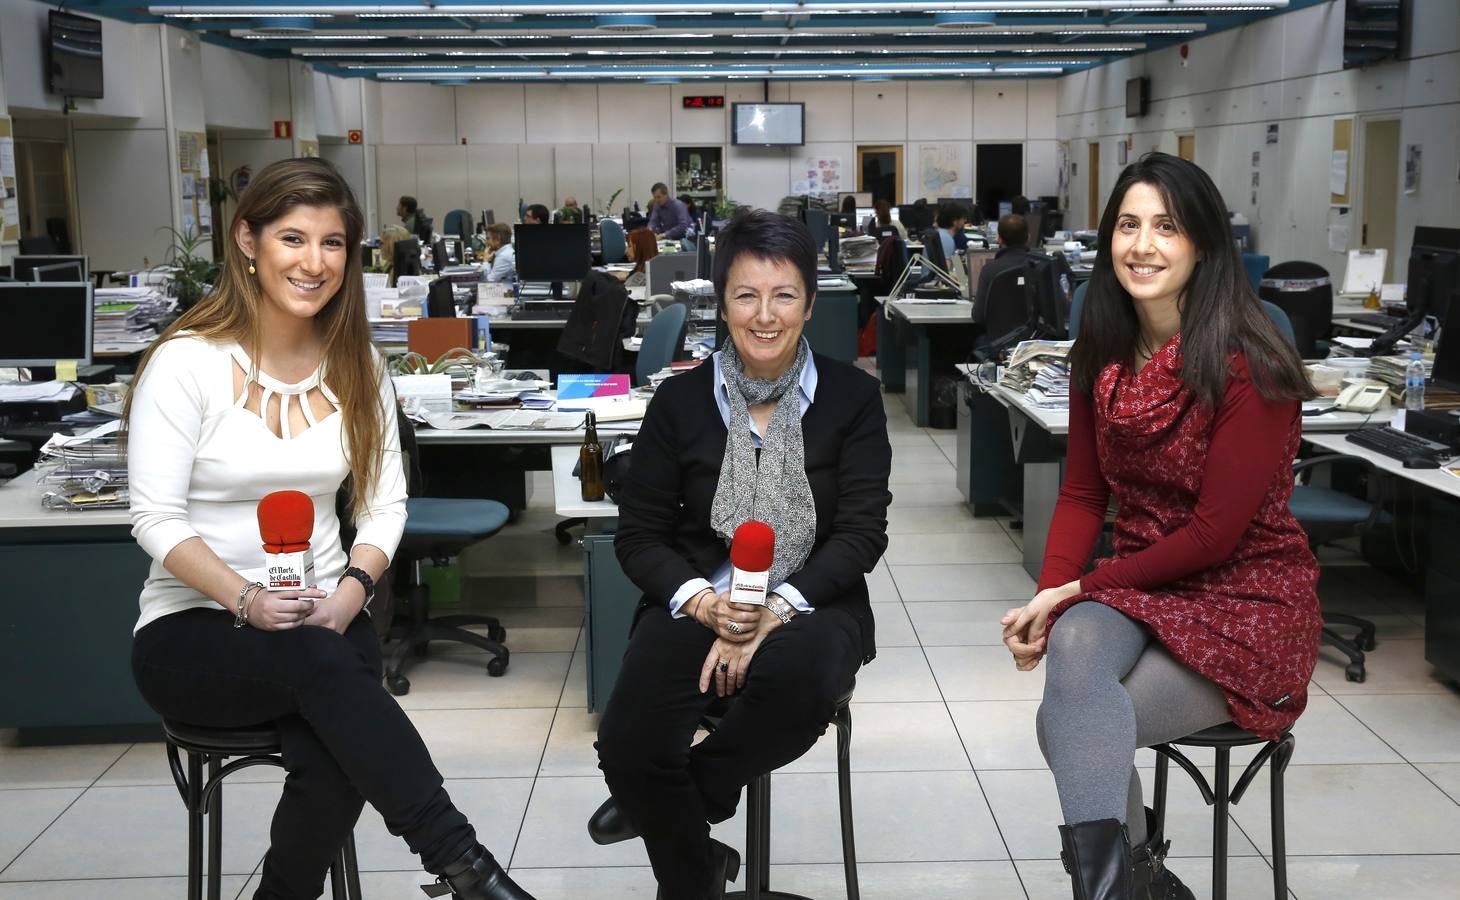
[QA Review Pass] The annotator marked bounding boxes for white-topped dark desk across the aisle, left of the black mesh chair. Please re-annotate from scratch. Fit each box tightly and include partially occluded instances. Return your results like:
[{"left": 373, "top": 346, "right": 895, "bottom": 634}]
[{"left": 877, "top": 298, "right": 974, "bottom": 428}]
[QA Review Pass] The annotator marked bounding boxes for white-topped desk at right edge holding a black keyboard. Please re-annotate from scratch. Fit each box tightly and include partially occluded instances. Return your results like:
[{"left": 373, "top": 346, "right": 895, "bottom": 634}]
[{"left": 1302, "top": 432, "right": 1460, "bottom": 682}]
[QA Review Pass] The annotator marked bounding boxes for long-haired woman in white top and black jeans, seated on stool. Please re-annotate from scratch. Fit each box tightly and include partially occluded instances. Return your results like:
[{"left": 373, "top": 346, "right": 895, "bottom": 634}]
[{"left": 127, "top": 159, "right": 531, "bottom": 900}]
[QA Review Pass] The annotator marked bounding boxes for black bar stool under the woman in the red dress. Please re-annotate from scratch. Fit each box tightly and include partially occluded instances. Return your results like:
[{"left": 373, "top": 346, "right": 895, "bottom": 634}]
[{"left": 1152, "top": 722, "right": 1296, "bottom": 900}]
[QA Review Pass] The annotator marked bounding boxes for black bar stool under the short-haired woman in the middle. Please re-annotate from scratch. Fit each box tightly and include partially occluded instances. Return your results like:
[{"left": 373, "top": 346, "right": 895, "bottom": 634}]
[{"left": 701, "top": 682, "right": 861, "bottom": 900}]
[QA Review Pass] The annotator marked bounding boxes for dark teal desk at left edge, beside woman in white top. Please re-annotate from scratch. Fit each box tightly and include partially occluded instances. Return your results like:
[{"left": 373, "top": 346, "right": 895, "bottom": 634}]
[{"left": 0, "top": 470, "right": 158, "bottom": 744}]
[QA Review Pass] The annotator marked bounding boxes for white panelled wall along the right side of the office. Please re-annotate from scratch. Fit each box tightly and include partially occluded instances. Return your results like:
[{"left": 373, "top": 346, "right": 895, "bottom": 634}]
[{"left": 1051, "top": 0, "right": 1460, "bottom": 278}]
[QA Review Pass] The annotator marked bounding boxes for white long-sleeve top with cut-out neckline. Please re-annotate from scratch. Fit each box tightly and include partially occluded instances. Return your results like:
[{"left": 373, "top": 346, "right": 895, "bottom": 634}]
[{"left": 127, "top": 338, "right": 406, "bottom": 631}]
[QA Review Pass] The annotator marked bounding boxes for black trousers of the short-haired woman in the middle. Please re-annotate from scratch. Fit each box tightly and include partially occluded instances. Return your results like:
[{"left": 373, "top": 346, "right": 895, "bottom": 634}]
[{"left": 597, "top": 606, "right": 861, "bottom": 900}]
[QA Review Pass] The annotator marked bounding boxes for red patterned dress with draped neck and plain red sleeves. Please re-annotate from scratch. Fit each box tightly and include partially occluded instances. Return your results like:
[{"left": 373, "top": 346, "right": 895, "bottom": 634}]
[{"left": 1040, "top": 335, "right": 1323, "bottom": 738}]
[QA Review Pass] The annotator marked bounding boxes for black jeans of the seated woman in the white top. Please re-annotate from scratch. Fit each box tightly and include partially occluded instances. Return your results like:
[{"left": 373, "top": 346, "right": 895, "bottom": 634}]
[{"left": 131, "top": 609, "right": 476, "bottom": 899}]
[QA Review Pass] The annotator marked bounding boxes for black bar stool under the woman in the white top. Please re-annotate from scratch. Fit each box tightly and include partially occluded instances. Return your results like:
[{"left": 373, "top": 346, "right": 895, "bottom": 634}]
[{"left": 162, "top": 719, "right": 361, "bottom": 900}]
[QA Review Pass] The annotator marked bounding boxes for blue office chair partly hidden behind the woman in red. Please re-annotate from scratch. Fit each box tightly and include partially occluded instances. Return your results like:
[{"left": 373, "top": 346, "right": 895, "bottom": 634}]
[{"left": 1261, "top": 300, "right": 1390, "bottom": 682}]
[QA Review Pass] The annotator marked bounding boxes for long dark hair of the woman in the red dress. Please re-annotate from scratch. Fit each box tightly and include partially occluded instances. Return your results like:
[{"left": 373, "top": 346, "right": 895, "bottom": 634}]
[{"left": 1070, "top": 153, "right": 1314, "bottom": 408}]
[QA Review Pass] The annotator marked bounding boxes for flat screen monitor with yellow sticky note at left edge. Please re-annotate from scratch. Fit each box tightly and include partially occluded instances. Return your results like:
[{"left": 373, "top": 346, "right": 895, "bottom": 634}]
[{"left": 0, "top": 282, "right": 93, "bottom": 367}]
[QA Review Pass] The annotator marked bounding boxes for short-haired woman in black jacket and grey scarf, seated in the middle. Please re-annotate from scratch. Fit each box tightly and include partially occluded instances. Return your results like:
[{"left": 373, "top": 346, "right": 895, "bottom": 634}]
[{"left": 588, "top": 210, "right": 892, "bottom": 900}]
